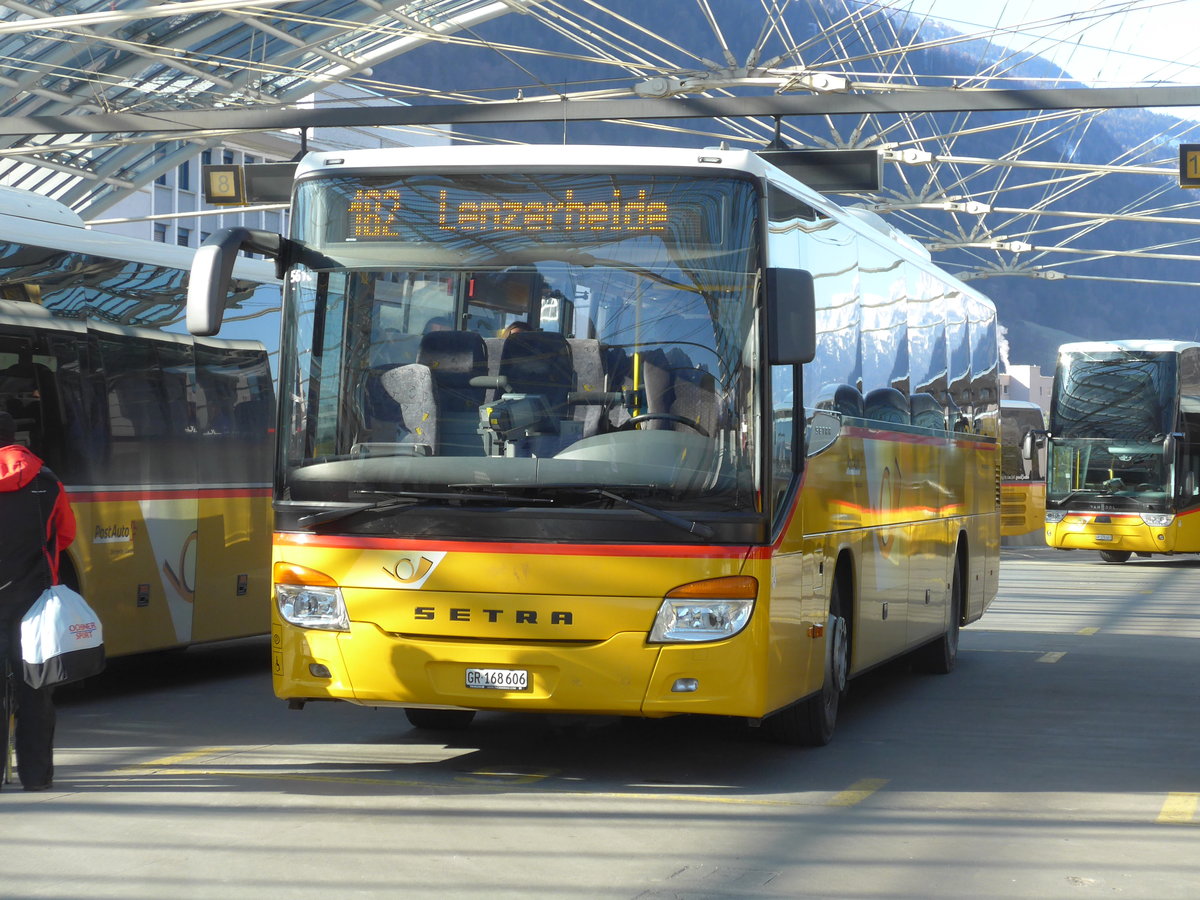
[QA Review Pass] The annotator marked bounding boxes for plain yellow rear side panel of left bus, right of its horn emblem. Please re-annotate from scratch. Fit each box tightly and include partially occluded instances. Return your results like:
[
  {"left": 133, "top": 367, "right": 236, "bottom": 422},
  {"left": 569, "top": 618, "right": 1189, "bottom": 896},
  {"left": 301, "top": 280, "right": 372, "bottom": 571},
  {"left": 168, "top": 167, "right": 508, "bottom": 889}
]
[{"left": 192, "top": 490, "right": 272, "bottom": 641}]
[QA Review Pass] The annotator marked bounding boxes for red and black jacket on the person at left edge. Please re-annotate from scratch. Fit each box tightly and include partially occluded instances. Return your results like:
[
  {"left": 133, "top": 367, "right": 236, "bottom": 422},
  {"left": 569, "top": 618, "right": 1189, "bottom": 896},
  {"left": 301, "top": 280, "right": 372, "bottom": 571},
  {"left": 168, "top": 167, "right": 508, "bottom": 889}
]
[{"left": 0, "top": 444, "right": 76, "bottom": 610}]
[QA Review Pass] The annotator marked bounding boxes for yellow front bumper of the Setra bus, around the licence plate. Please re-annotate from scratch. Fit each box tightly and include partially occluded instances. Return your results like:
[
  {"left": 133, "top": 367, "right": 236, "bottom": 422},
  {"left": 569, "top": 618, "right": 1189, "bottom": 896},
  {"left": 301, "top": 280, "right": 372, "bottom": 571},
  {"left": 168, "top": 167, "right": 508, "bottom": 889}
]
[{"left": 272, "top": 622, "right": 768, "bottom": 718}]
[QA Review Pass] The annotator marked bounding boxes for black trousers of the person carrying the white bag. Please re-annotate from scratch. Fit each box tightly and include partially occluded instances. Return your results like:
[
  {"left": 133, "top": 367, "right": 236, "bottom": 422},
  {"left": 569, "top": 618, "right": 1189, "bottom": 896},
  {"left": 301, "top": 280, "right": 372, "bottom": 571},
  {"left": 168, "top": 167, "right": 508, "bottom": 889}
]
[{"left": 0, "top": 607, "right": 55, "bottom": 787}]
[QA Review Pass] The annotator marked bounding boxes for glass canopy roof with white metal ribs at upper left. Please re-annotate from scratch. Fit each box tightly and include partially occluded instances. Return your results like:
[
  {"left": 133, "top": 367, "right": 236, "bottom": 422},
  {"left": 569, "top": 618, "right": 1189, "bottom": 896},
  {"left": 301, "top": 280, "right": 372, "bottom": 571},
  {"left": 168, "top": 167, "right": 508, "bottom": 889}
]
[{"left": 0, "top": 0, "right": 538, "bottom": 220}]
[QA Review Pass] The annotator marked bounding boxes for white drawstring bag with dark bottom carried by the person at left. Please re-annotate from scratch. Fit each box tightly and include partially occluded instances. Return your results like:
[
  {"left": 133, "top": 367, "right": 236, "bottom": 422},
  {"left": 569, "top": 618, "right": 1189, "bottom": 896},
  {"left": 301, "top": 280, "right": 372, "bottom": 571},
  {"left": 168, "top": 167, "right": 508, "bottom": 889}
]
[{"left": 20, "top": 584, "right": 104, "bottom": 688}]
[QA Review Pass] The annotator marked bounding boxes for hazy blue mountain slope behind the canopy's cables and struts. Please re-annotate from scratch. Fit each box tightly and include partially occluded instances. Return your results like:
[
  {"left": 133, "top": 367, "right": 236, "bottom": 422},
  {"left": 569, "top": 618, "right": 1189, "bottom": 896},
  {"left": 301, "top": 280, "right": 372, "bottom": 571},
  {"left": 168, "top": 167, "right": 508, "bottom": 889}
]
[{"left": 374, "top": 0, "right": 1200, "bottom": 371}]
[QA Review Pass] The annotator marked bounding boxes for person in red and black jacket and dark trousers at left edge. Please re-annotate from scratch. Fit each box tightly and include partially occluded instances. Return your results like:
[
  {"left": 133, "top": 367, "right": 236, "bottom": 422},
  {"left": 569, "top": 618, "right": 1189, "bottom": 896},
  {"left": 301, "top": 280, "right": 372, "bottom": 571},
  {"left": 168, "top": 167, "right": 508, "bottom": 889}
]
[{"left": 0, "top": 412, "right": 76, "bottom": 791}]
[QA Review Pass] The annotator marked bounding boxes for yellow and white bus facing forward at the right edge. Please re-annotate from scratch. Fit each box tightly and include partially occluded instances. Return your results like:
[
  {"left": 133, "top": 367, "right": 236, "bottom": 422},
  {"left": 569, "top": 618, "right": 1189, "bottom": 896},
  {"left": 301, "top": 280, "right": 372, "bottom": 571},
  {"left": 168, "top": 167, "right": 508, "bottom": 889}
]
[{"left": 1045, "top": 341, "right": 1200, "bottom": 563}]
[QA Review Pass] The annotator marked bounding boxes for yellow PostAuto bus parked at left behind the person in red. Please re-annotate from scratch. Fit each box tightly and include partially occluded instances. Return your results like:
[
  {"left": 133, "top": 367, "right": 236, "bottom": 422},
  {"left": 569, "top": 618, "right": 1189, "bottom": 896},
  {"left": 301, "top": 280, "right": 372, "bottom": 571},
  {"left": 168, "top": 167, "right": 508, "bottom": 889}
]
[{"left": 0, "top": 188, "right": 278, "bottom": 656}]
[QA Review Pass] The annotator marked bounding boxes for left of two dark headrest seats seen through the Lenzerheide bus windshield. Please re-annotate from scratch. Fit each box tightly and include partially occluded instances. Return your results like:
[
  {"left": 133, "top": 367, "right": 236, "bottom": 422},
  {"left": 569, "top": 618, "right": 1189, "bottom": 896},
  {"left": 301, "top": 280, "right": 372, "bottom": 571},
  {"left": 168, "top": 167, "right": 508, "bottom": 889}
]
[{"left": 416, "top": 331, "right": 487, "bottom": 456}]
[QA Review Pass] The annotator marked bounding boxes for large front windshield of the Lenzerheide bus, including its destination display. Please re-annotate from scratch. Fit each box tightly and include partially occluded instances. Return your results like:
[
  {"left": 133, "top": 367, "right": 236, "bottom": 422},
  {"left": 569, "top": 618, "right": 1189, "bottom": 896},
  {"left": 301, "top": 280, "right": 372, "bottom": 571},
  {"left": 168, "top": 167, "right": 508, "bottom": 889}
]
[{"left": 278, "top": 173, "right": 758, "bottom": 512}]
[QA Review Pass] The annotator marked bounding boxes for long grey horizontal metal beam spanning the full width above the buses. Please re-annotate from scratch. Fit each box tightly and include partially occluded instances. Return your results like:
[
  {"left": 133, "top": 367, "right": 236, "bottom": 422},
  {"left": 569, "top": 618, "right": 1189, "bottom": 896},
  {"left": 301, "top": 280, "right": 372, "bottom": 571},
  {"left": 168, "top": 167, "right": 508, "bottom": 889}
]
[{"left": 0, "top": 85, "right": 1200, "bottom": 136}]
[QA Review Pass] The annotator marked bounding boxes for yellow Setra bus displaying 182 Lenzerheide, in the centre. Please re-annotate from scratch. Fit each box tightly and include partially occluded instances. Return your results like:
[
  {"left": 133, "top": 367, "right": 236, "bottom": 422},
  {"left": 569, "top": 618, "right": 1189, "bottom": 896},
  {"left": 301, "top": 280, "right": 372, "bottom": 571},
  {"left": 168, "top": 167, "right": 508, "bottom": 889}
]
[{"left": 188, "top": 146, "right": 1000, "bottom": 744}]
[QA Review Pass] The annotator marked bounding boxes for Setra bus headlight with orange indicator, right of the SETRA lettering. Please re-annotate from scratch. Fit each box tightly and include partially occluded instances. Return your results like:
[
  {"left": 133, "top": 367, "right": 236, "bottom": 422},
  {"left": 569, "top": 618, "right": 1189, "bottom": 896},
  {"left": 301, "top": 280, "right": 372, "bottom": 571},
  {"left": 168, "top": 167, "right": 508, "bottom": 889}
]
[{"left": 649, "top": 576, "right": 758, "bottom": 643}]
